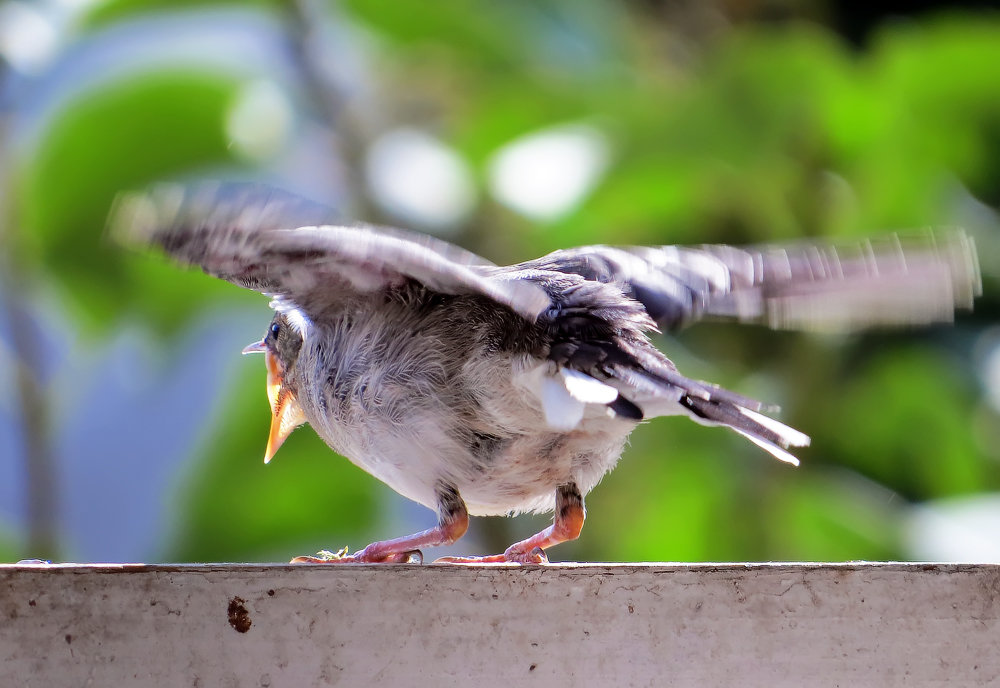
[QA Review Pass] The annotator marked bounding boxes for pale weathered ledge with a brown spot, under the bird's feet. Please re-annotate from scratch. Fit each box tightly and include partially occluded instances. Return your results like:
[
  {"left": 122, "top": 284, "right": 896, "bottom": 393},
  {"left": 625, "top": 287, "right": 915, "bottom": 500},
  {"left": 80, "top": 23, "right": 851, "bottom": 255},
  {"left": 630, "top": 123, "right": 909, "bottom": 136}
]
[{"left": 0, "top": 564, "right": 1000, "bottom": 688}]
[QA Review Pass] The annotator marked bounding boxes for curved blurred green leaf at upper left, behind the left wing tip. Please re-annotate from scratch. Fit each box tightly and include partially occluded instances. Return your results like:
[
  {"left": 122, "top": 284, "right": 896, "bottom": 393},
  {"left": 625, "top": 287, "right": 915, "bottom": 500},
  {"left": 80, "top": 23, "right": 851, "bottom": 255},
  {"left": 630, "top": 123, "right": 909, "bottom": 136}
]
[{"left": 17, "top": 71, "right": 246, "bottom": 331}]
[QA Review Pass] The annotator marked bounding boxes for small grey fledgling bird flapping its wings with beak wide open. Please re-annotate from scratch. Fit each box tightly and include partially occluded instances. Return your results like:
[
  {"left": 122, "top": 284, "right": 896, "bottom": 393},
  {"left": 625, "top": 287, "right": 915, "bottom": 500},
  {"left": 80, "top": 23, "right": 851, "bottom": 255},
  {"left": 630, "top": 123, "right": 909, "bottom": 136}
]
[{"left": 109, "top": 184, "right": 981, "bottom": 564}]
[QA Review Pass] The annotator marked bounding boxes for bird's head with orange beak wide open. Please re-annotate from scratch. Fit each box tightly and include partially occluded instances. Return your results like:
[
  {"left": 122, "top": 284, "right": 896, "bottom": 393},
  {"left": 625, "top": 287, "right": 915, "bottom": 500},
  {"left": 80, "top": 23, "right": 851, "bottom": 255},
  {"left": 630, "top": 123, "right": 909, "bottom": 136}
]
[{"left": 243, "top": 313, "right": 306, "bottom": 463}]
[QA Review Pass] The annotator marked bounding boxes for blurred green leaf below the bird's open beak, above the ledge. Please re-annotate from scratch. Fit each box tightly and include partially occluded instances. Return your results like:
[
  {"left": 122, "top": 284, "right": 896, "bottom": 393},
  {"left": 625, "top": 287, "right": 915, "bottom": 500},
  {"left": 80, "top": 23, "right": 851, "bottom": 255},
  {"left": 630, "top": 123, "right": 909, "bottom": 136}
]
[{"left": 168, "top": 366, "right": 379, "bottom": 561}]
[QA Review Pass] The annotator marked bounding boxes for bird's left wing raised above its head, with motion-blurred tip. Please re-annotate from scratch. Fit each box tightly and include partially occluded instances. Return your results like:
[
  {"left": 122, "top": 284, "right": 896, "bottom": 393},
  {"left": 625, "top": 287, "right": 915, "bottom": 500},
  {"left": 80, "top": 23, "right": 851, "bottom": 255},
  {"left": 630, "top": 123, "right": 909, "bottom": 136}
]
[{"left": 110, "top": 185, "right": 550, "bottom": 322}]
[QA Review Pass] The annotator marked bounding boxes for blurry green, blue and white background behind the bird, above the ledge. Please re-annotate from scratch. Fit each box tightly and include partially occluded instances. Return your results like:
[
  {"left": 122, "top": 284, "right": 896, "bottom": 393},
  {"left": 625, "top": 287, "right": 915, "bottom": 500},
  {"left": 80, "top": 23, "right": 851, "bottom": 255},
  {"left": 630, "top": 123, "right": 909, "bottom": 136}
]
[{"left": 0, "top": 0, "right": 1000, "bottom": 561}]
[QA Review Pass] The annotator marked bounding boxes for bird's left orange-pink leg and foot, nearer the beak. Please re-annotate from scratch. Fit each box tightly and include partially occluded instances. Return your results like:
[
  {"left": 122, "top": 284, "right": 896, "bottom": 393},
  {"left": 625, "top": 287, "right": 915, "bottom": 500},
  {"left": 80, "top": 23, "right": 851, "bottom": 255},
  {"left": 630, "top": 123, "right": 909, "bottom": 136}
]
[{"left": 292, "top": 485, "right": 469, "bottom": 564}]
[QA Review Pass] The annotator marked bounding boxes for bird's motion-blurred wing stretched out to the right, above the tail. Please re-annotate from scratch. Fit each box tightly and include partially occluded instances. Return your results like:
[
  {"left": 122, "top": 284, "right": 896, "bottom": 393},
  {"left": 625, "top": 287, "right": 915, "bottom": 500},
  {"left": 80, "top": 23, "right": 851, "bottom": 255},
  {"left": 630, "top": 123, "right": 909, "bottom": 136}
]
[{"left": 523, "top": 230, "right": 981, "bottom": 331}]
